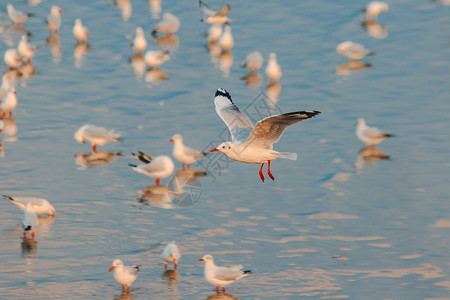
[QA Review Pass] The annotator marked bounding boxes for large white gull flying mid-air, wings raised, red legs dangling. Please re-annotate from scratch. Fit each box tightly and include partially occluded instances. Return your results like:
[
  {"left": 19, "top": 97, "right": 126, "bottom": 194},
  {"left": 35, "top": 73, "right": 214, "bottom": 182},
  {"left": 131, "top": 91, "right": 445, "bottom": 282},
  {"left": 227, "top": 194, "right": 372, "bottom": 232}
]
[{"left": 211, "top": 89, "right": 320, "bottom": 182}]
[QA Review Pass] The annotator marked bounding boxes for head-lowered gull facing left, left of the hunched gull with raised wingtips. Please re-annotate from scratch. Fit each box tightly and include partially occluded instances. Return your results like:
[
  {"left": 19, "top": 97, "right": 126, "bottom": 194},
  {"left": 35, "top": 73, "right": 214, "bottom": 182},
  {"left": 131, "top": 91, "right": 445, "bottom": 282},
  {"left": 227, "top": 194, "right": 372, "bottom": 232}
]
[{"left": 74, "top": 124, "right": 122, "bottom": 152}]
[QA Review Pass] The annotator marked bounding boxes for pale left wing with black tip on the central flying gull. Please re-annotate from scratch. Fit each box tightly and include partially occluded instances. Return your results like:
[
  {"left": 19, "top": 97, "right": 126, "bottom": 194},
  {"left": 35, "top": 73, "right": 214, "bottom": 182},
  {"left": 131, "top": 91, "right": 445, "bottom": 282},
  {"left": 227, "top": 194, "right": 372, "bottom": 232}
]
[{"left": 214, "top": 88, "right": 253, "bottom": 142}]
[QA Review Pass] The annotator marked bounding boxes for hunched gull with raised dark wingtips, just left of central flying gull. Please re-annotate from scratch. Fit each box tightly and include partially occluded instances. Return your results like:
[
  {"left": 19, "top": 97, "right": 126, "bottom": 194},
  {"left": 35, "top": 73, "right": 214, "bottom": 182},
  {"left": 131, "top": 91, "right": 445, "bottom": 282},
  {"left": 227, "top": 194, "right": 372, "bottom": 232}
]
[{"left": 129, "top": 151, "right": 175, "bottom": 185}]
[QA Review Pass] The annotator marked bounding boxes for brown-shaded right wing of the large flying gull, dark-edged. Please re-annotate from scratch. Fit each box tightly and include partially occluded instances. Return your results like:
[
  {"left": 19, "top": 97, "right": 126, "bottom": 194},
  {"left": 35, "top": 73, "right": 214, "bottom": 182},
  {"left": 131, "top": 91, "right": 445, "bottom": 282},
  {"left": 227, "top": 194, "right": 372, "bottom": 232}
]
[{"left": 245, "top": 110, "right": 320, "bottom": 149}]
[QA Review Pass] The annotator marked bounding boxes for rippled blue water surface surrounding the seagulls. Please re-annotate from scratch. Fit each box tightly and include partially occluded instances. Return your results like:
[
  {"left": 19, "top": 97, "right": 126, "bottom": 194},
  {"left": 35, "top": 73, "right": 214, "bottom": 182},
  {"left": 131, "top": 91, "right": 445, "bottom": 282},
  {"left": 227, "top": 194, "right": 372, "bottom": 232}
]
[{"left": 0, "top": 0, "right": 450, "bottom": 299}]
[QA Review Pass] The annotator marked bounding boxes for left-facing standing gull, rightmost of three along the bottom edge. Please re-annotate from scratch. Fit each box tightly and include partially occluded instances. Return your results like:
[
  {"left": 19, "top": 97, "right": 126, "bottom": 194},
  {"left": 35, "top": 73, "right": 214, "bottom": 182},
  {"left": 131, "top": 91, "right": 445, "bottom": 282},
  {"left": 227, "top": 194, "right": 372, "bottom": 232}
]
[{"left": 199, "top": 254, "right": 252, "bottom": 293}]
